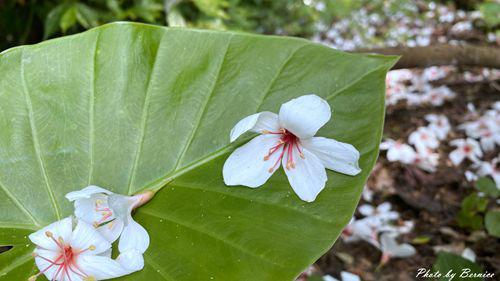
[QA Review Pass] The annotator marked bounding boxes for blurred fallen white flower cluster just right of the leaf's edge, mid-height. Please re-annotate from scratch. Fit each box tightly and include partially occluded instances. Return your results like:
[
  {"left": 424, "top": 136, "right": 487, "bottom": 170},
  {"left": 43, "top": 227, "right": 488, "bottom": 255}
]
[{"left": 380, "top": 114, "right": 451, "bottom": 173}]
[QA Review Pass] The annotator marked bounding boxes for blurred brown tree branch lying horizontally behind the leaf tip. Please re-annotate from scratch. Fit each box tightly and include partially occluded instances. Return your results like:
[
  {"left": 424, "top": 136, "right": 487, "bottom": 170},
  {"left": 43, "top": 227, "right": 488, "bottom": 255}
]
[{"left": 354, "top": 44, "right": 500, "bottom": 69}]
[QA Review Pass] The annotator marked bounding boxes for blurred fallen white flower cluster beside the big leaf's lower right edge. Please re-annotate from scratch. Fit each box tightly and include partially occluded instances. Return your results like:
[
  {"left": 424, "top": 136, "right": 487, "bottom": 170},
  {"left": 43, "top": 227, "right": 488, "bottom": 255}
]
[{"left": 341, "top": 202, "right": 416, "bottom": 264}]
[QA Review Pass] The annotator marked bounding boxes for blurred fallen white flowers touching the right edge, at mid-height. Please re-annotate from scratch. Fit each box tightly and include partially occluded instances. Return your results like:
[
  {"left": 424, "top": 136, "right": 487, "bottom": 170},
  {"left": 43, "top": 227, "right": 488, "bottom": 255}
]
[{"left": 449, "top": 101, "right": 500, "bottom": 189}]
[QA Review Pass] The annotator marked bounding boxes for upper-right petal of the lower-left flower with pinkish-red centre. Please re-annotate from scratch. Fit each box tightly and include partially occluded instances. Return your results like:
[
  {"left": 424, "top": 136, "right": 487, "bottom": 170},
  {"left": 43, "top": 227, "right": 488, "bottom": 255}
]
[{"left": 70, "top": 220, "right": 111, "bottom": 255}]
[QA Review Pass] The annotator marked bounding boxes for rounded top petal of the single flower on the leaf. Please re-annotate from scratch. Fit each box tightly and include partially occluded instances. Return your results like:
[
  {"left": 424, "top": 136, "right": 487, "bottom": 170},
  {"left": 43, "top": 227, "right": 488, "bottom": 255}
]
[{"left": 279, "top": 95, "right": 332, "bottom": 139}]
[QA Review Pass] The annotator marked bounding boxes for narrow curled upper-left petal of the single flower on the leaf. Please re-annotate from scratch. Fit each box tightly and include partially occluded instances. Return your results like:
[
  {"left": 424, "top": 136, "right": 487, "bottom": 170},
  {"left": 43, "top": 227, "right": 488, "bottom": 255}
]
[{"left": 230, "top": 111, "right": 280, "bottom": 142}]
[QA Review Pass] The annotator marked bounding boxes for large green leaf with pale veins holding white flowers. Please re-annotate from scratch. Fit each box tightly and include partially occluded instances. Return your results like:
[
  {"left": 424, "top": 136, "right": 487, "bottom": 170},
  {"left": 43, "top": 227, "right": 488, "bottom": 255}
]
[{"left": 0, "top": 23, "right": 396, "bottom": 281}]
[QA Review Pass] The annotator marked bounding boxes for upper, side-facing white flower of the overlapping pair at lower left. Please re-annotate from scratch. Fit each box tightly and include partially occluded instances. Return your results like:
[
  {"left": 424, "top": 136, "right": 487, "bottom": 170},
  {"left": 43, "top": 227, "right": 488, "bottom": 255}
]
[{"left": 66, "top": 185, "right": 153, "bottom": 257}]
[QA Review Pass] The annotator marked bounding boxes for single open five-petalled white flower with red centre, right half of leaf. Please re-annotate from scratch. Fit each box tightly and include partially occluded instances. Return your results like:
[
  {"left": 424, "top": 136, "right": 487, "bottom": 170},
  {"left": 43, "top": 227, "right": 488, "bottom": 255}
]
[{"left": 223, "top": 95, "right": 361, "bottom": 202}]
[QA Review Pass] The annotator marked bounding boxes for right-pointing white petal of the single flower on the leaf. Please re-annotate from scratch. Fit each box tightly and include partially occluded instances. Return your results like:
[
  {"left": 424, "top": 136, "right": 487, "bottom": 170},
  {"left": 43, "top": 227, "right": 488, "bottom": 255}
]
[{"left": 301, "top": 137, "right": 361, "bottom": 176}]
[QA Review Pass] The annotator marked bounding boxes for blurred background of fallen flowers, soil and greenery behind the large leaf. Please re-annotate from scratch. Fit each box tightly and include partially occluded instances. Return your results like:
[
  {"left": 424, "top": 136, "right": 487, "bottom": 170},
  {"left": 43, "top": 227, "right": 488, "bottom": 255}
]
[{"left": 0, "top": 0, "right": 500, "bottom": 281}]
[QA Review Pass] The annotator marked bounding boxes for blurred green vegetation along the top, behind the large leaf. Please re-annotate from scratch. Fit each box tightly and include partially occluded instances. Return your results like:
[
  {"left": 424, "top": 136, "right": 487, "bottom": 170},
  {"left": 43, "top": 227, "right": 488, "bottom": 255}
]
[{"left": 0, "top": 0, "right": 500, "bottom": 49}]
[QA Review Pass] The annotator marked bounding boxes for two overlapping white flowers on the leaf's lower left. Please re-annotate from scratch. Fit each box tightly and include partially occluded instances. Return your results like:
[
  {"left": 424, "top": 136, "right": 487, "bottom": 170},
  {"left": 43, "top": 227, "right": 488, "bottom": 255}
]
[{"left": 29, "top": 186, "right": 153, "bottom": 281}]
